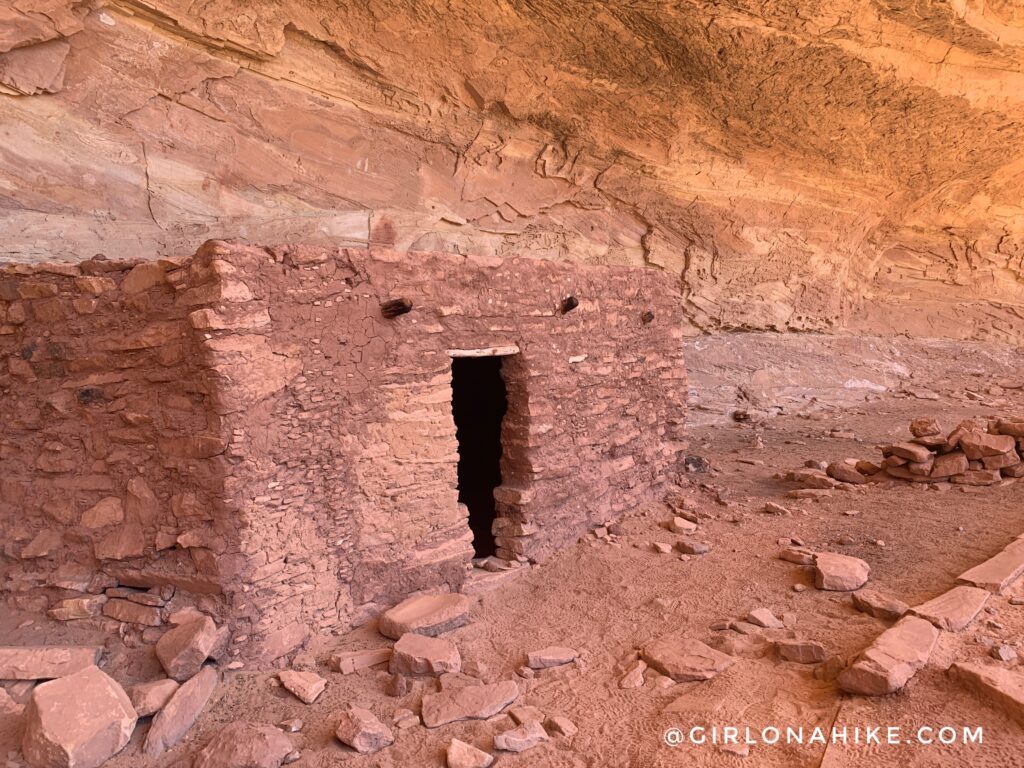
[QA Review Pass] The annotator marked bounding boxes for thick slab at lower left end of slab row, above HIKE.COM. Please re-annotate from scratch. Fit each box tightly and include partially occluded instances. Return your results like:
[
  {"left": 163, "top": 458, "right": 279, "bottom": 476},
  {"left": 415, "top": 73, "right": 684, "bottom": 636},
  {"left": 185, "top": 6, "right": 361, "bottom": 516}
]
[{"left": 837, "top": 616, "right": 939, "bottom": 696}]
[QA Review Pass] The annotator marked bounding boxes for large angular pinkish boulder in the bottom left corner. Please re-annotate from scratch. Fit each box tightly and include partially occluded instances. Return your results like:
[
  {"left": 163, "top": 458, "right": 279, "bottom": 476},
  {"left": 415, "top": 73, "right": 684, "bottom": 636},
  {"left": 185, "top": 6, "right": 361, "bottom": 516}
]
[{"left": 22, "top": 667, "right": 137, "bottom": 768}]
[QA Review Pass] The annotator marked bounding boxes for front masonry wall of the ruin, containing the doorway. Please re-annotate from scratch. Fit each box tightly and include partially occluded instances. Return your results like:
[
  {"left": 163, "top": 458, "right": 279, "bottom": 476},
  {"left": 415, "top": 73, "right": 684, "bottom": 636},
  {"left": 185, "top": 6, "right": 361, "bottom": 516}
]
[{"left": 193, "top": 243, "right": 686, "bottom": 655}]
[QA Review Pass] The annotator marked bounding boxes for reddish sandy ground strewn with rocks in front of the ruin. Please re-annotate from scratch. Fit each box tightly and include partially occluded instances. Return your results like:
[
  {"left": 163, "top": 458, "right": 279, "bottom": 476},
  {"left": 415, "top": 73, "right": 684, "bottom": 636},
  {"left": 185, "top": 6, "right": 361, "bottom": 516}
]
[{"left": 0, "top": 390, "right": 1024, "bottom": 768}]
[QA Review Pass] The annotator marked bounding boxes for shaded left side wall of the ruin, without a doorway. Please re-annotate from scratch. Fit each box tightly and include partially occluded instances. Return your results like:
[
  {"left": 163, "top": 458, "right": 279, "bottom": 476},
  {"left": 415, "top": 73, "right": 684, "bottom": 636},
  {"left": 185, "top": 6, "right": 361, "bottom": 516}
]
[{"left": 0, "top": 252, "right": 238, "bottom": 626}]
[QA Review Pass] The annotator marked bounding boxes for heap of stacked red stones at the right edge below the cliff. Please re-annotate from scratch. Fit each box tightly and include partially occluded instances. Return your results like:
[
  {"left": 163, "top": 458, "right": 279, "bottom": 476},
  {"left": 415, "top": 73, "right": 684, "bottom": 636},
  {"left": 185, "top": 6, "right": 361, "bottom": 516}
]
[{"left": 881, "top": 416, "right": 1024, "bottom": 485}]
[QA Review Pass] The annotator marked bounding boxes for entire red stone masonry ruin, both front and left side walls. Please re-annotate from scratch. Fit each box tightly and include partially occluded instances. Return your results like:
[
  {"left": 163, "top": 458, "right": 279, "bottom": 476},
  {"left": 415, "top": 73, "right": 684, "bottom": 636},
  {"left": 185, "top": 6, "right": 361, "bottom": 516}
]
[{"left": 0, "top": 241, "right": 686, "bottom": 659}]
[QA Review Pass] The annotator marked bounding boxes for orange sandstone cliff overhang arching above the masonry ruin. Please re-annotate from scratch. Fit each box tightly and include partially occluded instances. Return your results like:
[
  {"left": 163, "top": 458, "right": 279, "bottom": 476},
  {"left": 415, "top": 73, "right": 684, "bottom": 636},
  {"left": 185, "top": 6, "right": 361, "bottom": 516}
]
[{"left": 0, "top": 0, "right": 1024, "bottom": 341}]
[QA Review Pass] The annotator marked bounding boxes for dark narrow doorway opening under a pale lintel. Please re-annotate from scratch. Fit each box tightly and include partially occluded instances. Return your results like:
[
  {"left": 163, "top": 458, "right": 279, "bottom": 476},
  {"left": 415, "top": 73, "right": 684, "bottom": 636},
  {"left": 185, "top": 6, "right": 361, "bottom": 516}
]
[{"left": 452, "top": 356, "right": 508, "bottom": 557}]
